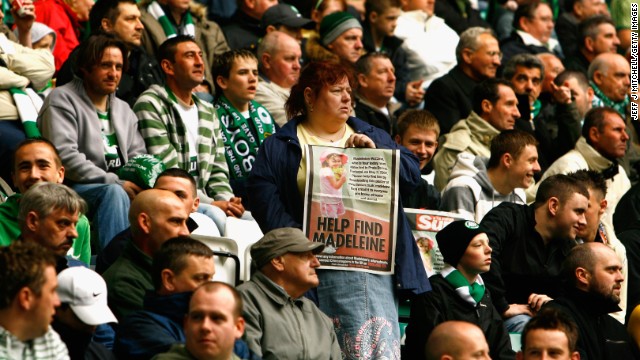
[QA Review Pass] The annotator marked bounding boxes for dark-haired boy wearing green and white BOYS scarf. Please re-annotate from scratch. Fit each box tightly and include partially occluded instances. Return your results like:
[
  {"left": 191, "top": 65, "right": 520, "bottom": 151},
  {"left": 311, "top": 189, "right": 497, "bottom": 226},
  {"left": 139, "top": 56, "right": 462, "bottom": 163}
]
[{"left": 213, "top": 50, "right": 276, "bottom": 205}]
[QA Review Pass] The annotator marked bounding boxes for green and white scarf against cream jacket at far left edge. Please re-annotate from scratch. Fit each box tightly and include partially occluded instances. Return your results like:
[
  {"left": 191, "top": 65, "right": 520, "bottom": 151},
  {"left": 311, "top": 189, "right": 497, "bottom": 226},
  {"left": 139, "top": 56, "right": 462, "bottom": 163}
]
[{"left": 0, "top": 34, "right": 43, "bottom": 138}]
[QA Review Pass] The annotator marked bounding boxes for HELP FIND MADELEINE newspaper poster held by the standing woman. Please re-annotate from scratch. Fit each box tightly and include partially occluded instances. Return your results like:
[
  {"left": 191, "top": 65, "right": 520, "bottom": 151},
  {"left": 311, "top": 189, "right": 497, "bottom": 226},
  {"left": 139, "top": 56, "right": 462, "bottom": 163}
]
[{"left": 303, "top": 146, "right": 400, "bottom": 274}]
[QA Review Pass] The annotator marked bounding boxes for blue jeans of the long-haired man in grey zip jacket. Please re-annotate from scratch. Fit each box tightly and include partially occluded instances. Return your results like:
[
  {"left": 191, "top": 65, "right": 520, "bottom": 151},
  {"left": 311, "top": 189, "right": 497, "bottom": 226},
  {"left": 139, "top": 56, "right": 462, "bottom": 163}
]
[{"left": 73, "top": 184, "right": 131, "bottom": 252}]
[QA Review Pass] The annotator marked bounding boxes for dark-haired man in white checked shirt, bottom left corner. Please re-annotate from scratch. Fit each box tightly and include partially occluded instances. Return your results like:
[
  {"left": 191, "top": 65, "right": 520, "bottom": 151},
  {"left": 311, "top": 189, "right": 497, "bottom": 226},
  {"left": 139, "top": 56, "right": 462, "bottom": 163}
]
[{"left": 0, "top": 241, "right": 69, "bottom": 360}]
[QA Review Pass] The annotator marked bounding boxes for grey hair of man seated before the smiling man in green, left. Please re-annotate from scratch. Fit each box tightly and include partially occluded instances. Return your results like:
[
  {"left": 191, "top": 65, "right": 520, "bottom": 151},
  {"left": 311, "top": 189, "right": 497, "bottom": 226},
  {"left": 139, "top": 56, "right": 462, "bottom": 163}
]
[{"left": 18, "top": 182, "right": 87, "bottom": 227}]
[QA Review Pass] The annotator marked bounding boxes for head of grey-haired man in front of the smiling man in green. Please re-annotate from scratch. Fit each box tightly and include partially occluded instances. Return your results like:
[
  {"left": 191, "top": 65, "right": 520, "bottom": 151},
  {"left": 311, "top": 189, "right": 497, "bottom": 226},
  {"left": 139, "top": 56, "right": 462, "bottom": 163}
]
[{"left": 18, "top": 182, "right": 87, "bottom": 272}]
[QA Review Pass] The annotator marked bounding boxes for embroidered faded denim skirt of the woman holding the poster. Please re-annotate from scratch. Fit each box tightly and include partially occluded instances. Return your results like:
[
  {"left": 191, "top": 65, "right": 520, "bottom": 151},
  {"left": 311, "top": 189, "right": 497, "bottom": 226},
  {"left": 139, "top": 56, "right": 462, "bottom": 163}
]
[{"left": 318, "top": 270, "right": 400, "bottom": 360}]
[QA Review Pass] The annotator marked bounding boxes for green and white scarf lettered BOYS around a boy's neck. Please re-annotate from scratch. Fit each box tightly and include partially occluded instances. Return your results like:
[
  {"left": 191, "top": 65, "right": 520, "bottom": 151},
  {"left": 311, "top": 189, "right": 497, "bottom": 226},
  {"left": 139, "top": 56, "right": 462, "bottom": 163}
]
[{"left": 215, "top": 96, "right": 275, "bottom": 179}]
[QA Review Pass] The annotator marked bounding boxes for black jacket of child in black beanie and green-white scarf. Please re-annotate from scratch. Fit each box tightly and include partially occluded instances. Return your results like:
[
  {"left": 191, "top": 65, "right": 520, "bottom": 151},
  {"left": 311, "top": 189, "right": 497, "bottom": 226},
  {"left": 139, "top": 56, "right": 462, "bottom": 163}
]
[{"left": 403, "top": 274, "right": 515, "bottom": 360}]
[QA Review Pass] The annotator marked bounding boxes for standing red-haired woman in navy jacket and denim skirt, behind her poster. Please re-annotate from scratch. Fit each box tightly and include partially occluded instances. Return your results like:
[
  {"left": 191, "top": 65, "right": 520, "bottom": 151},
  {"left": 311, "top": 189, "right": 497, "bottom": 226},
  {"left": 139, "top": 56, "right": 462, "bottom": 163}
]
[{"left": 248, "top": 62, "right": 431, "bottom": 359}]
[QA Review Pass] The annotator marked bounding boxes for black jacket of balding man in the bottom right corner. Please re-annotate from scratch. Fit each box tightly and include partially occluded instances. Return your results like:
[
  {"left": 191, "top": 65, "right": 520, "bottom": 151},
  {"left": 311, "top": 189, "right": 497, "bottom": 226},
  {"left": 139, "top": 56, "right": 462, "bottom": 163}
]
[{"left": 544, "top": 286, "right": 638, "bottom": 360}]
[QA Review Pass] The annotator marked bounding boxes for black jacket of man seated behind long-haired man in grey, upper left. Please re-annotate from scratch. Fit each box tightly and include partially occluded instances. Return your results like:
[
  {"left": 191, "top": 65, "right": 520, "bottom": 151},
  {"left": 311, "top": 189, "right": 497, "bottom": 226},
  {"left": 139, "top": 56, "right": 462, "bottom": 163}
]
[{"left": 56, "top": 47, "right": 164, "bottom": 107}]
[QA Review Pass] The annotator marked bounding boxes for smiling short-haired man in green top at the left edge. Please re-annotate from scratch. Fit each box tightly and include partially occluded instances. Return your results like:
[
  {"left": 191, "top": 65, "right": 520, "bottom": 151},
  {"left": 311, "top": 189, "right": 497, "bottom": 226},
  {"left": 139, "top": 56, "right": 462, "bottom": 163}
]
[{"left": 0, "top": 138, "right": 91, "bottom": 265}]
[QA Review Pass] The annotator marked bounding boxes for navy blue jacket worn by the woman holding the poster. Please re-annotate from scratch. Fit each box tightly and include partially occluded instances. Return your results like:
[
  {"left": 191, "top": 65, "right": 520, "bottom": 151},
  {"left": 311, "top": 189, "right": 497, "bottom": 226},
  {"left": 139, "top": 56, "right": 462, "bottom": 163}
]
[{"left": 248, "top": 117, "right": 431, "bottom": 294}]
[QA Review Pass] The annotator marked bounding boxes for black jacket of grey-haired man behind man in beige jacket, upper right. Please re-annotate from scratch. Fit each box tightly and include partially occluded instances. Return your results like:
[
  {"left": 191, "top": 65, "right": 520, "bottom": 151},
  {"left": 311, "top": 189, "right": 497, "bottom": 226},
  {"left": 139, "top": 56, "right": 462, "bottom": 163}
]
[{"left": 424, "top": 66, "right": 478, "bottom": 136}]
